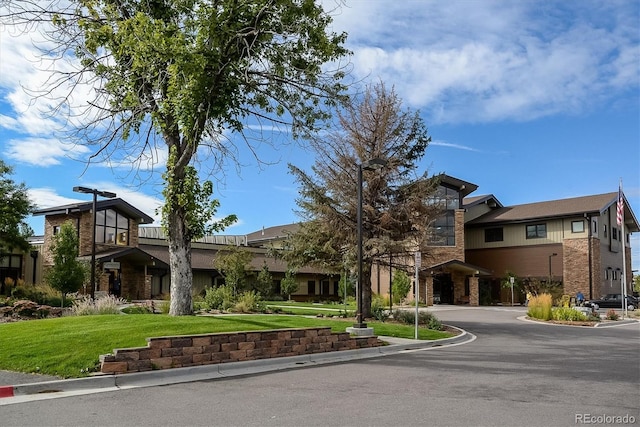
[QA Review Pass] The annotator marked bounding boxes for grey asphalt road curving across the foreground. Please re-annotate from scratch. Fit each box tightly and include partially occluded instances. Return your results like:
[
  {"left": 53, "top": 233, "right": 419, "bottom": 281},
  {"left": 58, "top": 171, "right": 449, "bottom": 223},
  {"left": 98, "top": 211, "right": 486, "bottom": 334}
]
[{"left": 0, "top": 306, "right": 640, "bottom": 426}]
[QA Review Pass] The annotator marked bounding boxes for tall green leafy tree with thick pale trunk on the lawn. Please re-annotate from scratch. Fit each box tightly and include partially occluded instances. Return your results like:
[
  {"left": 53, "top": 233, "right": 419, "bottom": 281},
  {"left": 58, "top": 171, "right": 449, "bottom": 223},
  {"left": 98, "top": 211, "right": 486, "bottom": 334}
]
[{"left": 2, "top": 0, "right": 348, "bottom": 315}]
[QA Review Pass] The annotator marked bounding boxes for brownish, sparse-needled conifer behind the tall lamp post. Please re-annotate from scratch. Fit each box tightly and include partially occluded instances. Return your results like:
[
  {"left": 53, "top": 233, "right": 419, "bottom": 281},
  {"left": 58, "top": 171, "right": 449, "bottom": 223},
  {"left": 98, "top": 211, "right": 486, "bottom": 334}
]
[{"left": 283, "top": 83, "right": 440, "bottom": 317}]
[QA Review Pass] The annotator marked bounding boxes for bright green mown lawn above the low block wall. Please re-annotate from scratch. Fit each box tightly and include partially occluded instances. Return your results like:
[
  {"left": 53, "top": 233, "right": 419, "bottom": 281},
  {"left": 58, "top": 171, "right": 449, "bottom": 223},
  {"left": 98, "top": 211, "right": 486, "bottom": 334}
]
[{"left": 0, "top": 314, "right": 450, "bottom": 378}]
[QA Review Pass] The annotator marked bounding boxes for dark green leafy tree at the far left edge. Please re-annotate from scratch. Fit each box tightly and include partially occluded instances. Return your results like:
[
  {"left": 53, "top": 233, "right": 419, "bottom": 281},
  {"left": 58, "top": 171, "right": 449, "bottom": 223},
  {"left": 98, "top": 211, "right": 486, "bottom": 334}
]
[{"left": 0, "top": 160, "right": 34, "bottom": 255}]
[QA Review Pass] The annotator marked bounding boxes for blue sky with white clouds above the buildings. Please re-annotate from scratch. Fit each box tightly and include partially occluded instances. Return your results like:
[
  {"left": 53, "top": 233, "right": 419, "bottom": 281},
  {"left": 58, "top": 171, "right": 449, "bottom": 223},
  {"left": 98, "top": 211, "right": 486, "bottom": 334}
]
[{"left": 0, "top": 0, "right": 640, "bottom": 269}]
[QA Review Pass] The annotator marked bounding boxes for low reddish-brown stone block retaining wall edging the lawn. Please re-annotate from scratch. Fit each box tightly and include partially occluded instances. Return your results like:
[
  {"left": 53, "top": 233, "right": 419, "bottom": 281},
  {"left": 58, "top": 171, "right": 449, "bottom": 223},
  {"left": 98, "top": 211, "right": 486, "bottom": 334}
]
[{"left": 100, "top": 327, "right": 382, "bottom": 374}]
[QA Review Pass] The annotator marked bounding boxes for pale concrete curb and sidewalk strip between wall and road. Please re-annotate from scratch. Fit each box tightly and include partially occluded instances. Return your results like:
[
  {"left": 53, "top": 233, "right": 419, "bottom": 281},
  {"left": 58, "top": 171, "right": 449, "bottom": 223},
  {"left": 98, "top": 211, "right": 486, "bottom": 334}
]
[{"left": 0, "top": 330, "right": 474, "bottom": 406}]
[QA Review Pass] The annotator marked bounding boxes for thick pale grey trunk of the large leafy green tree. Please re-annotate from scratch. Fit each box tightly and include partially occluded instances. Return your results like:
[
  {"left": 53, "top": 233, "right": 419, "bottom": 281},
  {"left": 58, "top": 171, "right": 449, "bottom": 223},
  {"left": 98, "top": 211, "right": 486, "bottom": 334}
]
[{"left": 168, "top": 204, "right": 193, "bottom": 316}]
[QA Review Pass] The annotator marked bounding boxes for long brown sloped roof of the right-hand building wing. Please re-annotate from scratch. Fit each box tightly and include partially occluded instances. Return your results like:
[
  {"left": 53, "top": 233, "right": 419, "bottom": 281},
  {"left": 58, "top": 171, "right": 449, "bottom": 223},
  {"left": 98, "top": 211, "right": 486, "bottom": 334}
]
[{"left": 467, "top": 192, "right": 639, "bottom": 232}]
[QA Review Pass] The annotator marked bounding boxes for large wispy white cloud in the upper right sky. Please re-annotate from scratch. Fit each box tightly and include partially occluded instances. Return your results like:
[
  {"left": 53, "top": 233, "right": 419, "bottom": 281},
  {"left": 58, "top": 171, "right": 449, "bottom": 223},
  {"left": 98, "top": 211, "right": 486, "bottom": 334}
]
[{"left": 325, "top": 0, "right": 639, "bottom": 123}]
